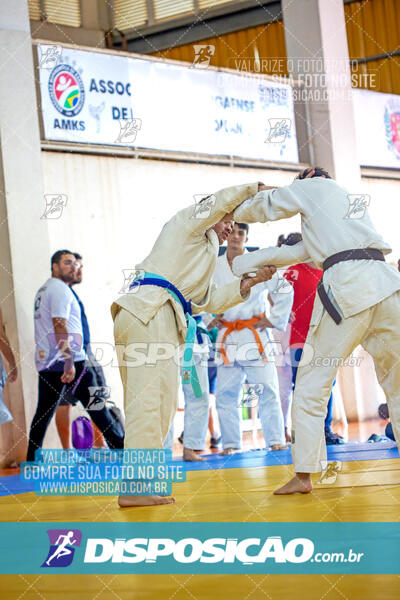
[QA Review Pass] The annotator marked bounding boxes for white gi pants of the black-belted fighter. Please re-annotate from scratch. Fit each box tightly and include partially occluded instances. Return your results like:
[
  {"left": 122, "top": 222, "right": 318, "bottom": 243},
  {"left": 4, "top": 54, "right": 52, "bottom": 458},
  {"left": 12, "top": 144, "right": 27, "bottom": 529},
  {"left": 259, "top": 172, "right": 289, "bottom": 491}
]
[{"left": 292, "top": 291, "right": 400, "bottom": 473}]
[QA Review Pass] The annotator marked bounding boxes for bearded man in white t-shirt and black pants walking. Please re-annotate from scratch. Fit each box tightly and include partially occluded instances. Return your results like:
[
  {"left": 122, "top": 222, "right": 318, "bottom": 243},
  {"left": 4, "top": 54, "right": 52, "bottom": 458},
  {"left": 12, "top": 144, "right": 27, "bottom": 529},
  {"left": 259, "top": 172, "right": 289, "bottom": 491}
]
[{"left": 27, "top": 250, "right": 123, "bottom": 461}]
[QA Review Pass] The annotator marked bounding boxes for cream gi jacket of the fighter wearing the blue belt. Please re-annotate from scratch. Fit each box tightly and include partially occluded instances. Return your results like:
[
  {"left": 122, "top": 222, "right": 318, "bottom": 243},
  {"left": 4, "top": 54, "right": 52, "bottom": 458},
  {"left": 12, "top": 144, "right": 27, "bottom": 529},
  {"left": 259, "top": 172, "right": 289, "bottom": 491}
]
[{"left": 111, "top": 183, "right": 258, "bottom": 342}]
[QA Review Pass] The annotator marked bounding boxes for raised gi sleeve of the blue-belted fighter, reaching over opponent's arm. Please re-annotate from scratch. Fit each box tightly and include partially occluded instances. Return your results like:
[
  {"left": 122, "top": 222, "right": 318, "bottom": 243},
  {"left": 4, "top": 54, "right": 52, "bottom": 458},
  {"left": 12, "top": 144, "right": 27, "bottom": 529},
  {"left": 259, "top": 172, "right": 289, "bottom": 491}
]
[{"left": 177, "top": 183, "right": 258, "bottom": 235}]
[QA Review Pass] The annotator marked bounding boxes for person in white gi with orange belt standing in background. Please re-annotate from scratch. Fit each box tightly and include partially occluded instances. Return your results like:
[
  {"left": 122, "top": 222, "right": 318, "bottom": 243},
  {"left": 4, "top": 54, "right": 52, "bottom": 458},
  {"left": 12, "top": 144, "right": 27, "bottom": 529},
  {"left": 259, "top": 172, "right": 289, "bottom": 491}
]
[{"left": 213, "top": 223, "right": 293, "bottom": 454}]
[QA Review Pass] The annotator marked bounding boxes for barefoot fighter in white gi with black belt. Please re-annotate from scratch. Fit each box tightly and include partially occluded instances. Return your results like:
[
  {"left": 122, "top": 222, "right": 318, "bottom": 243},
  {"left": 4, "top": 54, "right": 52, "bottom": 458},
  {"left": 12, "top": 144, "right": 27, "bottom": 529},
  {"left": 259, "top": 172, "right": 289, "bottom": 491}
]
[{"left": 233, "top": 167, "right": 400, "bottom": 494}]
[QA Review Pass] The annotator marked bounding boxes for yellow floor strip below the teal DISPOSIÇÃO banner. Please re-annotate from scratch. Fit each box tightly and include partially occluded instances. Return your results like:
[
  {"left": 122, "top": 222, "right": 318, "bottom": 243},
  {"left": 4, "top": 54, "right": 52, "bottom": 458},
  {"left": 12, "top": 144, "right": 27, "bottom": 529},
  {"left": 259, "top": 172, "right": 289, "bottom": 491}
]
[{"left": 0, "top": 575, "right": 400, "bottom": 600}]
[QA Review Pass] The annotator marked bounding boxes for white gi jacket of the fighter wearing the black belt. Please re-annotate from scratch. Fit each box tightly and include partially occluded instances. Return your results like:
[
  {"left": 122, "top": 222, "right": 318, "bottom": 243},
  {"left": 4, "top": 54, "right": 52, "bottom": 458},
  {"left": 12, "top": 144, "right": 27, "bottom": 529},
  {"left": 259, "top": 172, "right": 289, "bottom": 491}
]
[{"left": 233, "top": 177, "right": 400, "bottom": 324}]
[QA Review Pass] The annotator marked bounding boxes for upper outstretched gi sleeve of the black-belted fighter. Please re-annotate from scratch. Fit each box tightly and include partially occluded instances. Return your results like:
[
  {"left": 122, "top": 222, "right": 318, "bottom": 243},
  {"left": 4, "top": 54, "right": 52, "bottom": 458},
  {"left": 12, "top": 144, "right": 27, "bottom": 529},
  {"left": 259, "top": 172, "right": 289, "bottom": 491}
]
[{"left": 234, "top": 179, "right": 305, "bottom": 223}]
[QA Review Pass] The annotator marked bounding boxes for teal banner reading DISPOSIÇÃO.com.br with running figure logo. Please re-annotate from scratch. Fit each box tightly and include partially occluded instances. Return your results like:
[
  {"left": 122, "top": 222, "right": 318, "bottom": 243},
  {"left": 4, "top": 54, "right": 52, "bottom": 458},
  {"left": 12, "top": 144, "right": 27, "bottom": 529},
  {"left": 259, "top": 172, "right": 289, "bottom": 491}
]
[{"left": 0, "top": 522, "right": 400, "bottom": 574}]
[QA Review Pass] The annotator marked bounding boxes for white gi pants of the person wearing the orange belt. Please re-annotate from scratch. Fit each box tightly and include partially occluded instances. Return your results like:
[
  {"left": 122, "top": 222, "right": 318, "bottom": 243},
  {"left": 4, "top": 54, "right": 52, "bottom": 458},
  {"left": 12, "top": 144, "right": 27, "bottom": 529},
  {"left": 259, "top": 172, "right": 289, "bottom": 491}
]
[{"left": 215, "top": 360, "right": 284, "bottom": 450}]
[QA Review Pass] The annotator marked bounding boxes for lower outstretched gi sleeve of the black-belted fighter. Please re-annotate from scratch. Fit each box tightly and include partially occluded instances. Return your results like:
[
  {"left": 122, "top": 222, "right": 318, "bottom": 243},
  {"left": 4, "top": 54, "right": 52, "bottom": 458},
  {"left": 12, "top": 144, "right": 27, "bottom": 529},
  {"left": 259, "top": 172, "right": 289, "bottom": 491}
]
[{"left": 232, "top": 242, "right": 311, "bottom": 277}]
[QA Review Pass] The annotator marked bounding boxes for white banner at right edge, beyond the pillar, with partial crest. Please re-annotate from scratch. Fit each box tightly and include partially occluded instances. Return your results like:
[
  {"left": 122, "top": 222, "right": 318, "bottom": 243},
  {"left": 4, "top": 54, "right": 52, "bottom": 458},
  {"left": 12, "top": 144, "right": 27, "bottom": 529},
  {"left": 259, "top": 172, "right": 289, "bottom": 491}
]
[{"left": 353, "top": 90, "right": 400, "bottom": 168}]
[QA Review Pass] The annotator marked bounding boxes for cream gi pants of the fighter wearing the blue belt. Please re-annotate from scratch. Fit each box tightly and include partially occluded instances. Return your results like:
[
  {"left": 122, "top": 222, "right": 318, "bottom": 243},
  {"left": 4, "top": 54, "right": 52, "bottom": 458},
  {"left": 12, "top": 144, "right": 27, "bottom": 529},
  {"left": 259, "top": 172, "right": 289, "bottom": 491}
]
[{"left": 114, "top": 302, "right": 179, "bottom": 448}]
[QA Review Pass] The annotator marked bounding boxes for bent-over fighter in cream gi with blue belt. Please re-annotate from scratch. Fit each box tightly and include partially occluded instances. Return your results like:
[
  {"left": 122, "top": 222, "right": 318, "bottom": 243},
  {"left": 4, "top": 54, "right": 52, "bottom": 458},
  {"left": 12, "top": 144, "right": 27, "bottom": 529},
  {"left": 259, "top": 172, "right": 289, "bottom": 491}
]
[{"left": 111, "top": 183, "right": 275, "bottom": 506}]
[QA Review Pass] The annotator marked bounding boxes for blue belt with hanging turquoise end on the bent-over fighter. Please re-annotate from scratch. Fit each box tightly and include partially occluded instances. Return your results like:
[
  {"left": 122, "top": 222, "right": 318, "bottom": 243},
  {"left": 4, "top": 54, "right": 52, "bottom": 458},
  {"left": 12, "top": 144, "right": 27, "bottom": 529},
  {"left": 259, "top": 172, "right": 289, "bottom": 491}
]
[{"left": 129, "top": 273, "right": 203, "bottom": 398}]
